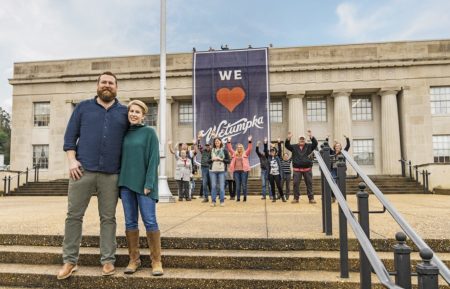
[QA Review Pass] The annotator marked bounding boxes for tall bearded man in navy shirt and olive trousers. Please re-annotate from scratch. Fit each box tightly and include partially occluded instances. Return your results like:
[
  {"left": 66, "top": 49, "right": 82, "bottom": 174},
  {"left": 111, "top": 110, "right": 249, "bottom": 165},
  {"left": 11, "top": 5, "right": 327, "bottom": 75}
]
[{"left": 57, "top": 71, "right": 128, "bottom": 280}]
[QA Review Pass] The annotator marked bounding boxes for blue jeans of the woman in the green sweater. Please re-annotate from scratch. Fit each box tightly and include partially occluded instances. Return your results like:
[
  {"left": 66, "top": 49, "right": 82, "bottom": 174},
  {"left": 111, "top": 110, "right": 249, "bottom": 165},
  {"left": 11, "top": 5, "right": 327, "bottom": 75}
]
[{"left": 120, "top": 187, "right": 159, "bottom": 232}]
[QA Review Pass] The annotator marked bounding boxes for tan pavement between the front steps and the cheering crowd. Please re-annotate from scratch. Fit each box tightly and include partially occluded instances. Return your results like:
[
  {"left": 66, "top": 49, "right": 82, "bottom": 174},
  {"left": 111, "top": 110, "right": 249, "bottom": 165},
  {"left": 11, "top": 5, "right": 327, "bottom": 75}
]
[{"left": 0, "top": 195, "right": 450, "bottom": 239}]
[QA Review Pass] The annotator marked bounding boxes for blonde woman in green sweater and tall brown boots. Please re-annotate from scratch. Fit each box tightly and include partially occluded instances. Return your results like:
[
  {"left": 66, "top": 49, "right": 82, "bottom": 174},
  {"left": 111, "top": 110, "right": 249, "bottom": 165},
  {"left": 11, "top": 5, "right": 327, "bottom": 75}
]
[{"left": 119, "top": 100, "right": 163, "bottom": 276}]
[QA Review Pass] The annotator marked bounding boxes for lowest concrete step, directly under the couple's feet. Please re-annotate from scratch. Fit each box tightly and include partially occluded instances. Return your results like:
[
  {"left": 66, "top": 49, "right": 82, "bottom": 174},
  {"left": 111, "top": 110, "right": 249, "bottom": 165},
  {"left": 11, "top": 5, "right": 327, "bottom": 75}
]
[{"left": 0, "top": 264, "right": 448, "bottom": 289}]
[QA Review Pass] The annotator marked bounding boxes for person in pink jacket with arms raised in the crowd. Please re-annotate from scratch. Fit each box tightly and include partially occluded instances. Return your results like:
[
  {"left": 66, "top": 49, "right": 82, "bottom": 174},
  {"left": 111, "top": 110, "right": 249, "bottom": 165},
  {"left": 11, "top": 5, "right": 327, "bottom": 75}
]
[{"left": 227, "top": 136, "right": 252, "bottom": 202}]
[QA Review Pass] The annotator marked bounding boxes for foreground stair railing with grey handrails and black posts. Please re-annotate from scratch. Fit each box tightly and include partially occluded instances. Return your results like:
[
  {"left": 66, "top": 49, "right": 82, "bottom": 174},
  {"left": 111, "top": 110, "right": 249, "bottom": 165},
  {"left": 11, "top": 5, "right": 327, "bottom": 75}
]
[{"left": 314, "top": 143, "right": 448, "bottom": 289}]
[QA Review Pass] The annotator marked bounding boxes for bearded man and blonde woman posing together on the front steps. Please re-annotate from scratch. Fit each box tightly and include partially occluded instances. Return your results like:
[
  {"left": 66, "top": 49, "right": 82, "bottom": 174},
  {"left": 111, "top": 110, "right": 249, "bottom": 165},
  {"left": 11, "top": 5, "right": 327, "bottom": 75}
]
[{"left": 57, "top": 72, "right": 163, "bottom": 280}]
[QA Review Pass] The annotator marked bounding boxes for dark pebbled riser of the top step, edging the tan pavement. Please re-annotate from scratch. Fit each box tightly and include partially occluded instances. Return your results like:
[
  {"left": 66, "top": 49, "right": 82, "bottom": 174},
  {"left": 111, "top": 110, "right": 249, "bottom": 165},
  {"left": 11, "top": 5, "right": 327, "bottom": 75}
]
[{"left": 0, "top": 234, "right": 450, "bottom": 253}]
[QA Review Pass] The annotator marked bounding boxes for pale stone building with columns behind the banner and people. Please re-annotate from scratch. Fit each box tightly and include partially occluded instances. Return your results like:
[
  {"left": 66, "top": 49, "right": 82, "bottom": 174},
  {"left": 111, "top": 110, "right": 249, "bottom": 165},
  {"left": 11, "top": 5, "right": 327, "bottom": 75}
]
[{"left": 10, "top": 40, "right": 450, "bottom": 187}]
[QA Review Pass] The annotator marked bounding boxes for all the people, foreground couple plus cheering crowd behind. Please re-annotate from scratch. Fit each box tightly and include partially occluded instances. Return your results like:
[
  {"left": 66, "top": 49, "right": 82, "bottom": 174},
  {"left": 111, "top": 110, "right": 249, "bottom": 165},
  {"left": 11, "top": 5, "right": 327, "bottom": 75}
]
[{"left": 57, "top": 72, "right": 350, "bottom": 280}]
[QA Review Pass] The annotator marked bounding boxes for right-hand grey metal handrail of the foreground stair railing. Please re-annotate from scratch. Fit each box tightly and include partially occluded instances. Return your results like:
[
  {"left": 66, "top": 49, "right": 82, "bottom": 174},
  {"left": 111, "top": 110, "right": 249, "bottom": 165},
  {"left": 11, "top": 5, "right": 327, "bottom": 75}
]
[{"left": 342, "top": 151, "right": 450, "bottom": 284}]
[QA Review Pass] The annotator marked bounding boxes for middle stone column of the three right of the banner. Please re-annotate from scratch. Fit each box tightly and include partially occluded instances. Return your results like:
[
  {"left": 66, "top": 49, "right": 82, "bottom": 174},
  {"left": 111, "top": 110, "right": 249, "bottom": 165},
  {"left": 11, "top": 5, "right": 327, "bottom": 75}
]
[{"left": 330, "top": 90, "right": 352, "bottom": 143}]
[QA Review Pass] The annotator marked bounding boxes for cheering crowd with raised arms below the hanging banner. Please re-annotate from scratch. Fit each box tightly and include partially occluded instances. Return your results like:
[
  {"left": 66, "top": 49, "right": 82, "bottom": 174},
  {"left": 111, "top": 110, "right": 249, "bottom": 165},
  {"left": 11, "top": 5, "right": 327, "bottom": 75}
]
[{"left": 169, "top": 130, "right": 350, "bottom": 207}]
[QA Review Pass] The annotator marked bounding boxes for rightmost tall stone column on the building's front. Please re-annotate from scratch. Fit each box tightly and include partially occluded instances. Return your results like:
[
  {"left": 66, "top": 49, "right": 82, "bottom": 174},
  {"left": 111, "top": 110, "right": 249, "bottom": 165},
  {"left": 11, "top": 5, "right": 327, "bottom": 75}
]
[{"left": 379, "top": 88, "right": 401, "bottom": 175}]
